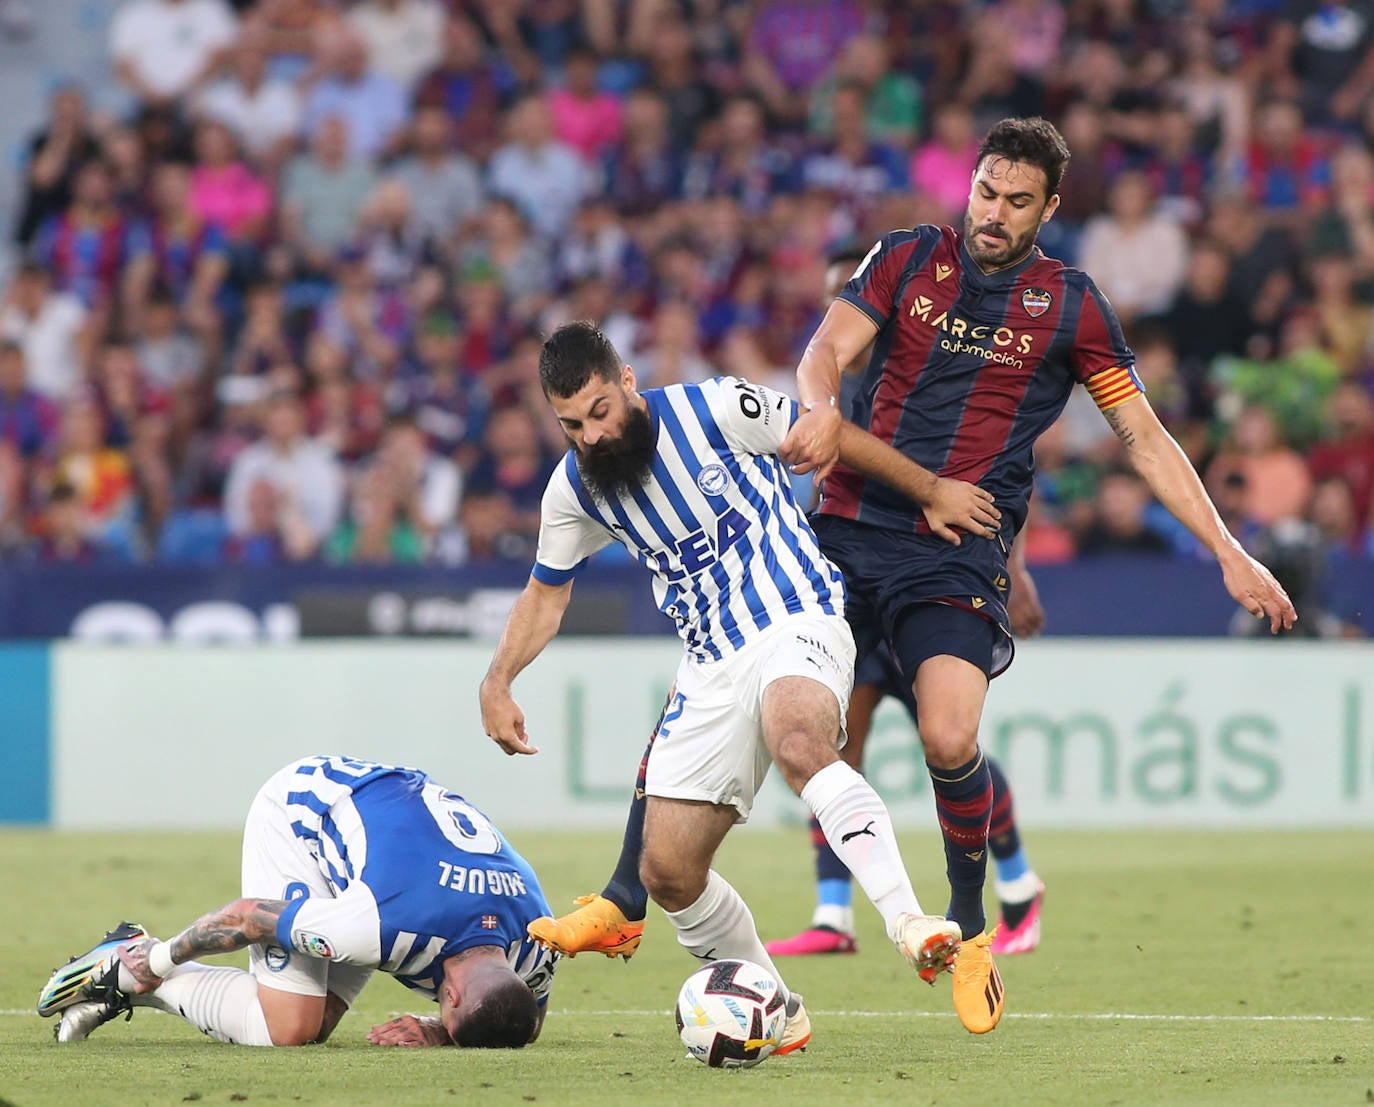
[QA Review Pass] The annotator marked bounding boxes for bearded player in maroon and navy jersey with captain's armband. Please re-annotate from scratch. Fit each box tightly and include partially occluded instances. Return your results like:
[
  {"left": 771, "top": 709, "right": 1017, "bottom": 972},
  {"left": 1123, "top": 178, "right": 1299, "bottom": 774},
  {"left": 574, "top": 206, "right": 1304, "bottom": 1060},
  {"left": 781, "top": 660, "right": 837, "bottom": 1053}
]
[{"left": 782, "top": 118, "right": 1297, "bottom": 1033}]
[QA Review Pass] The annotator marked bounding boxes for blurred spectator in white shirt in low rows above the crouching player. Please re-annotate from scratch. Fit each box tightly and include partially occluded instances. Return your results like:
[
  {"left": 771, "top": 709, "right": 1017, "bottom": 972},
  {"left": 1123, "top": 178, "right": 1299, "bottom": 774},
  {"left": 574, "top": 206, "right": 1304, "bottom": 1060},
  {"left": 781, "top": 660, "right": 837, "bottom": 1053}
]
[{"left": 224, "top": 393, "right": 344, "bottom": 558}]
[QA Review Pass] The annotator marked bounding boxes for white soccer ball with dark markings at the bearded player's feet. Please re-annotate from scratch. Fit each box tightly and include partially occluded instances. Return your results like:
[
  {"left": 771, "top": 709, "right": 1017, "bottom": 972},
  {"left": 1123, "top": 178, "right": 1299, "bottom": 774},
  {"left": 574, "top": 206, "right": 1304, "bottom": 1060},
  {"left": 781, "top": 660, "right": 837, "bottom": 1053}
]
[{"left": 673, "top": 961, "right": 787, "bottom": 1069}]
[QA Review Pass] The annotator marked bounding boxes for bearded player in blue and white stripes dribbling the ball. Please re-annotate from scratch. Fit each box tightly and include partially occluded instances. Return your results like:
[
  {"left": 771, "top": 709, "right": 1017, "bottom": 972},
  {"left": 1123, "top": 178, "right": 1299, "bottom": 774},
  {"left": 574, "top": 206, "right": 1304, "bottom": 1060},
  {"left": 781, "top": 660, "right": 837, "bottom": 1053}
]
[{"left": 481, "top": 323, "right": 999, "bottom": 1053}]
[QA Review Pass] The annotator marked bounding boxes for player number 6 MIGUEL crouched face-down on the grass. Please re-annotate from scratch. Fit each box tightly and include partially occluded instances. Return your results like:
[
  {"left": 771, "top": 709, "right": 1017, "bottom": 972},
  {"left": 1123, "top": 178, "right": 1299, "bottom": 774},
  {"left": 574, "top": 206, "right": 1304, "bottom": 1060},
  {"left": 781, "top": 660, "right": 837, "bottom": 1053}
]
[{"left": 38, "top": 755, "right": 558, "bottom": 1048}]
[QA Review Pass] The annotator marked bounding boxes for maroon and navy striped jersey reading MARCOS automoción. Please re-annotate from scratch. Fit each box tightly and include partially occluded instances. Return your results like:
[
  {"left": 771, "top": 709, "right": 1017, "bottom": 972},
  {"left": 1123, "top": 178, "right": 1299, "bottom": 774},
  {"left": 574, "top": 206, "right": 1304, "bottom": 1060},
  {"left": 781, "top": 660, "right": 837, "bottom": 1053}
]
[{"left": 820, "top": 225, "right": 1143, "bottom": 533}]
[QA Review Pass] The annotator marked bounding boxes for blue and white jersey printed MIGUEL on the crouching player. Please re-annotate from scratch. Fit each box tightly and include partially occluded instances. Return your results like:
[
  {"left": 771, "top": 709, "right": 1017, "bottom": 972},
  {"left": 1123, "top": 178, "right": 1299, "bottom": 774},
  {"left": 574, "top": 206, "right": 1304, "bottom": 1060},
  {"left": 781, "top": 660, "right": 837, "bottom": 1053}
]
[{"left": 276, "top": 755, "right": 558, "bottom": 1008}]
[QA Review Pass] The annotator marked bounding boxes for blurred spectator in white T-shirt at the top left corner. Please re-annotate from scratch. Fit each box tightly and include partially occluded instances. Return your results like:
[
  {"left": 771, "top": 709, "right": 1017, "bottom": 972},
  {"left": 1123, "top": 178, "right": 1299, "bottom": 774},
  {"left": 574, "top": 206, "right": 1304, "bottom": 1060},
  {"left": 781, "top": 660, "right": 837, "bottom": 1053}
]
[{"left": 110, "top": 0, "right": 238, "bottom": 107}]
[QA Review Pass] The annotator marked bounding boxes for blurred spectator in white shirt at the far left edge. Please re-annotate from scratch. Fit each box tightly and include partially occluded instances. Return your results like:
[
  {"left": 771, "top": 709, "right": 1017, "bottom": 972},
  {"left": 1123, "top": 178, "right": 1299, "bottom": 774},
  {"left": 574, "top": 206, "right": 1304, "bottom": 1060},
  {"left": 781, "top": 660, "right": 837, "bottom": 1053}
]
[{"left": 0, "top": 262, "right": 93, "bottom": 401}]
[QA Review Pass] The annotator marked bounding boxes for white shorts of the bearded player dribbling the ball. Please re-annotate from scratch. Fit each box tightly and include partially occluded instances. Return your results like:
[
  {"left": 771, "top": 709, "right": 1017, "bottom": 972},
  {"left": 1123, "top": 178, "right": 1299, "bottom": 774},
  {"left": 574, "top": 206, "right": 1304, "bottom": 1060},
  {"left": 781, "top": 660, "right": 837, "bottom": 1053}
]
[{"left": 644, "top": 614, "right": 855, "bottom": 823}]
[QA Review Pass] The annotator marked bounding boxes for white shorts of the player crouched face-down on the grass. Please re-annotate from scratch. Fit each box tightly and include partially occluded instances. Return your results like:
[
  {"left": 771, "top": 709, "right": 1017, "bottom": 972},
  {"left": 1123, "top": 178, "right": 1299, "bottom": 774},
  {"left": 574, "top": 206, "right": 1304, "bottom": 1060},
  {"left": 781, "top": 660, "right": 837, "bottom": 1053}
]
[{"left": 243, "top": 764, "right": 374, "bottom": 1007}]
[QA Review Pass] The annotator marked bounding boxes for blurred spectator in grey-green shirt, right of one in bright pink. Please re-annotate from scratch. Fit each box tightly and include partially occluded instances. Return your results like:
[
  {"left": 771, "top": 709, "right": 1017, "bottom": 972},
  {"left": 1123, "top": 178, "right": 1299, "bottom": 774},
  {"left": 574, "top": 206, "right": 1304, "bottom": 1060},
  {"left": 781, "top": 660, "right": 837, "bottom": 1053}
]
[{"left": 282, "top": 115, "right": 376, "bottom": 275}]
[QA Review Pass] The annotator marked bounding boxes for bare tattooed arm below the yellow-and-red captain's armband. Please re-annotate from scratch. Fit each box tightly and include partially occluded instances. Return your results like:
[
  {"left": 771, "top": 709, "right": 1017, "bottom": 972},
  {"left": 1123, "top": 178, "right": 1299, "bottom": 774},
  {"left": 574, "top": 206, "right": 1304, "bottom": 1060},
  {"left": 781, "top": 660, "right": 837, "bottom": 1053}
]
[{"left": 1102, "top": 396, "right": 1297, "bottom": 633}]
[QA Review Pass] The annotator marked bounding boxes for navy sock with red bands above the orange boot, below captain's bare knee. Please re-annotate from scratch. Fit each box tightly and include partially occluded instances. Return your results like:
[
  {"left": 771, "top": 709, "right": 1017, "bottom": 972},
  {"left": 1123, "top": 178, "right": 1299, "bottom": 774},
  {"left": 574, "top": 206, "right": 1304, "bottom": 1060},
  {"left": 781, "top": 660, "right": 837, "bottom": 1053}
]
[{"left": 926, "top": 750, "right": 992, "bottom": 938}]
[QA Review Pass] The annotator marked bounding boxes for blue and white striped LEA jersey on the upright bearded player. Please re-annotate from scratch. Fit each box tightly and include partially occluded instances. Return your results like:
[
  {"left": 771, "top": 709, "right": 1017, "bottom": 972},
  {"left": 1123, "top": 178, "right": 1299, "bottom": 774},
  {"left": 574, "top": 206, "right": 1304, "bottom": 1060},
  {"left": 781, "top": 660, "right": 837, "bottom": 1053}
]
[{"left": 533, "top": 376, "right": 845, "bottom": 661}]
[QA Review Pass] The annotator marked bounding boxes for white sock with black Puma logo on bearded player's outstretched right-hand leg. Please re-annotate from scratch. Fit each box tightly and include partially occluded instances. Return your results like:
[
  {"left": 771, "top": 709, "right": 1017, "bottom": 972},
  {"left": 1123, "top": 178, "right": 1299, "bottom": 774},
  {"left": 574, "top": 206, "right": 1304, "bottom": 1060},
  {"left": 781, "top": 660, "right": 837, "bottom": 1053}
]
[{"left": 801, "top": 761, "right": 925, "bottom": 933}]
